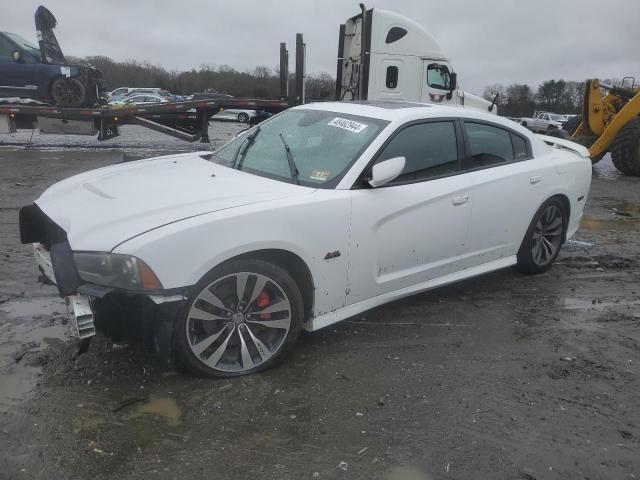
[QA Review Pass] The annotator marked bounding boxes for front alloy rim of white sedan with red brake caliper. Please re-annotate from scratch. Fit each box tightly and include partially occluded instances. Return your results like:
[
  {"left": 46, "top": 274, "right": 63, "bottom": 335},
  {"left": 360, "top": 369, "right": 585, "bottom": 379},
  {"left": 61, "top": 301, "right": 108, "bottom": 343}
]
[{"left": 186, "top": 272, "right": 292, "bottom": 373}]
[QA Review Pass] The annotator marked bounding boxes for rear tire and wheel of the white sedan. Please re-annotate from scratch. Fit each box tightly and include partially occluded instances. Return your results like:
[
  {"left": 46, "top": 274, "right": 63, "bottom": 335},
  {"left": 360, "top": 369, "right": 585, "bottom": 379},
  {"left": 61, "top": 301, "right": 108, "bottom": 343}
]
[{"left": 518, "top": 197, "right": 568, "bottom": 274}]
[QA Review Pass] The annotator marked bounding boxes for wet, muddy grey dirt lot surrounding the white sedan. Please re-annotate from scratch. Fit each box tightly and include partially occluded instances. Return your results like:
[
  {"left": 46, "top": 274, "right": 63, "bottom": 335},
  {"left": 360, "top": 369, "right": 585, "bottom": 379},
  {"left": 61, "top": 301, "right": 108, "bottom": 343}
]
[{"left": 0, "top": 129, "right": 640, "bottom": 480}]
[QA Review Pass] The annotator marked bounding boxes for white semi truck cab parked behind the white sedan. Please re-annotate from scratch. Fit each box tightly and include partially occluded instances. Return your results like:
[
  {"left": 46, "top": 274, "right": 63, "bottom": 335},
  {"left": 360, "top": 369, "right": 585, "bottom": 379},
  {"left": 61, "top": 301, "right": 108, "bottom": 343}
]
[{"left": 336, "top": 4, "right": 497, "bottom": 113}]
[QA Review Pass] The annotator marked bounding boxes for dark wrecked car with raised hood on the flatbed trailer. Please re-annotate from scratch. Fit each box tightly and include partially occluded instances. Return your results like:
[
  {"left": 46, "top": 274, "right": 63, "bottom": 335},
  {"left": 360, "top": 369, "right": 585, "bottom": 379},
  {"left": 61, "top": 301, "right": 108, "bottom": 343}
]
[{"left": 0, "top": 6, "right": 104, "bottom": 107}]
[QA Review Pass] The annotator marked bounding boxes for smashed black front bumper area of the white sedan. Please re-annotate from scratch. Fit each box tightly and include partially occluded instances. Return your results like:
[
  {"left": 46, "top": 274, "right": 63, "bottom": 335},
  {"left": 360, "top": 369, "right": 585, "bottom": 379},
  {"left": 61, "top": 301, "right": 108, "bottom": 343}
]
[{"left": 20, "top": 204, "right": 186, "bottom": 366}]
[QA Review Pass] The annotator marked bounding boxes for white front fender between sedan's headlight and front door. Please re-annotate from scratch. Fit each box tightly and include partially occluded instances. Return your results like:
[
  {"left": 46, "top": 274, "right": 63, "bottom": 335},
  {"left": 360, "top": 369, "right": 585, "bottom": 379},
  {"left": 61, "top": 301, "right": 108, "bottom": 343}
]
[{"left": 113, "top": 190, "right": 351, "bottom": 314}]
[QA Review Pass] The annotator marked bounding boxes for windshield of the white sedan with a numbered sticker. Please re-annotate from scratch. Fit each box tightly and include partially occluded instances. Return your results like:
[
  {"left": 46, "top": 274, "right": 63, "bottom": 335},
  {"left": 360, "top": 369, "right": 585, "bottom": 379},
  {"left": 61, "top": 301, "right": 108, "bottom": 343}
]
[{"left": 211, "top": 110, "right": 389, "bottom": 188}]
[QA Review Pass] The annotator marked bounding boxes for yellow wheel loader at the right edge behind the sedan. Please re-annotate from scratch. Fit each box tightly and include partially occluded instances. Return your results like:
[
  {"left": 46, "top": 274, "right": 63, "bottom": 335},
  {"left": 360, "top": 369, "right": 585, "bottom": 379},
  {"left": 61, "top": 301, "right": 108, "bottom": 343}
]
[{"left": 563, "top": 77, "right": 640, "bottom": 177}]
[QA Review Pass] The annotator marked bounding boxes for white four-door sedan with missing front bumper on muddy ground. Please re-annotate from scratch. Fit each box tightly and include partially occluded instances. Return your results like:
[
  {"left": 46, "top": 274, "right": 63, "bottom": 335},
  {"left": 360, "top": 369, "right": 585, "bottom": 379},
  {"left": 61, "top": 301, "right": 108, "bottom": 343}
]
[{"left": 20, "top": 102, "right": 591, "bottom": 377}]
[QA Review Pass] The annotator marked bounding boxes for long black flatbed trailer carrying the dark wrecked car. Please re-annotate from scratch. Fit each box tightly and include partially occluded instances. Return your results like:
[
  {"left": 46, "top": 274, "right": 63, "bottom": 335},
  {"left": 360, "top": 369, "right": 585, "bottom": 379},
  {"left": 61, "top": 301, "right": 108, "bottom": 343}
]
[{"left": 0, "top": 98, "right": 292, "bottom": 143}]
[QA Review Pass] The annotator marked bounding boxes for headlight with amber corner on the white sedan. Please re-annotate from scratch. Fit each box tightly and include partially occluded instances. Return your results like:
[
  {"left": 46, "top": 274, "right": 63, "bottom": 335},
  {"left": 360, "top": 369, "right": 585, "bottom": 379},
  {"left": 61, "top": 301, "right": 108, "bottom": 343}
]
[{"left": 73, "top": 252, "right": 162, "bottom": 290}]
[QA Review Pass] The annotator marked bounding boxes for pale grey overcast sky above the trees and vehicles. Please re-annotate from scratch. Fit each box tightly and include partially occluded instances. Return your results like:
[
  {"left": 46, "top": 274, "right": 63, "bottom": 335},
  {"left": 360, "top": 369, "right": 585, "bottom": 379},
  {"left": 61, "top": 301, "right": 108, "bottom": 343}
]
[{"left": 5, "top": 0, "right": 640, "bottom": 93}]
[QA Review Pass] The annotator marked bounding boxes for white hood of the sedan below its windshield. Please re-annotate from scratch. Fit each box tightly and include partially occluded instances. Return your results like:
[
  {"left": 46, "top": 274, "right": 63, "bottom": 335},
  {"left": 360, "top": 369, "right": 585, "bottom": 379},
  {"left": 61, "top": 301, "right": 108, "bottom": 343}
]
[{"left": 35, "top": 152, "right": 315, "bottom": 251}]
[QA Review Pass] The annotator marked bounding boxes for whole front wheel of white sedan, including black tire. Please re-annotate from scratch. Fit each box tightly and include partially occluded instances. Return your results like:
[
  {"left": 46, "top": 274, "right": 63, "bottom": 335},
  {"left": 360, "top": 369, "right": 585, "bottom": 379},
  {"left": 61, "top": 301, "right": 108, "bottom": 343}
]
[{"left": 174, "top": 260, "right": 304, "bottom": 378}]
